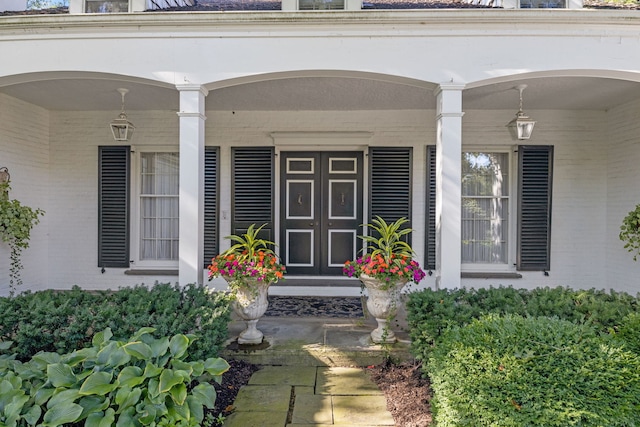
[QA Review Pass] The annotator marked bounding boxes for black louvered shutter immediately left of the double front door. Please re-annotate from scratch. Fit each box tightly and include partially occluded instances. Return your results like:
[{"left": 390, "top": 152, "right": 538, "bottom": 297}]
[{"left": 231, "top": 147, "right": 274, "bottom": 241}]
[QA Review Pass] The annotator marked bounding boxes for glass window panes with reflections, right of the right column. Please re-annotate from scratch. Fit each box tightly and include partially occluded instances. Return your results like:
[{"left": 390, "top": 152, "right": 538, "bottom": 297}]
[{"left": 461, "top": 152, "right": 510, "bottom": 264}]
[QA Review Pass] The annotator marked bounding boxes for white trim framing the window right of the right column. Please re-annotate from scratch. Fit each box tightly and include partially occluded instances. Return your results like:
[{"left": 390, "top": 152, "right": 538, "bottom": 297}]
[{"left": 460, "top": 145, "right": 518, "bottom": 273}]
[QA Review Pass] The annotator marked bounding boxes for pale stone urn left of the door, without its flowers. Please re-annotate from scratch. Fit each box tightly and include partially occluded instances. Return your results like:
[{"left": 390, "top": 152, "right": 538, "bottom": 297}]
[{"left": 231, "top": 279, "right": 269, "bottom": 344}]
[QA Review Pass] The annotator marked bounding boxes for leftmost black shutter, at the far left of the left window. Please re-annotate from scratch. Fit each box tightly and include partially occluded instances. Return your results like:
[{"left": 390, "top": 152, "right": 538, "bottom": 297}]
[{"left": 98, "top": 146, "right": 130, "bottom": 268}]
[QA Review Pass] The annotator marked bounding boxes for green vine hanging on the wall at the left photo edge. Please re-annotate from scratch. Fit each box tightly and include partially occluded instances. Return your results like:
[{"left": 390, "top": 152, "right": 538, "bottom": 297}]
[{"left": 0, "top": 182, "right": 44, "bottom": 294}]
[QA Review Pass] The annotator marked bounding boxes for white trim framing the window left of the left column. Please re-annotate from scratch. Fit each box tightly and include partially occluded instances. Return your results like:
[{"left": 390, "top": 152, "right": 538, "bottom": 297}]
[{"left": 129, "top": 146, "right": 180, "bottom": 270}]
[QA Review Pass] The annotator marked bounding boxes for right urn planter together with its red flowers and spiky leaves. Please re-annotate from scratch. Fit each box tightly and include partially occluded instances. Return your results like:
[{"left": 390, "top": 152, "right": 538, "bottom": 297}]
[{"left": 343, "top": 216, "right": 425, "bottom": 343}]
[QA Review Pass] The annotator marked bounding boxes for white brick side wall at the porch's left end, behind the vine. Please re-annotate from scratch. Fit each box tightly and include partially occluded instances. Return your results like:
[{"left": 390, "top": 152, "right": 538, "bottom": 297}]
[{"left": 0, "top": 93, "right": 49, "bottom": 295}]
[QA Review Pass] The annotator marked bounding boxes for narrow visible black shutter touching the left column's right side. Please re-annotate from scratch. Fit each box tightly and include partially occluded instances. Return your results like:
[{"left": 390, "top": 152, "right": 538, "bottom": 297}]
[{"left": 204, "top": 147, "right": 220, "bottom": 268}]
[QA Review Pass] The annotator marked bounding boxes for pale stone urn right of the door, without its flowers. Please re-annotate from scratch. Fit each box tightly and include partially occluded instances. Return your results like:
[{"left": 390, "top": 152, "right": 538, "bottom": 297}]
[{"left": 360, "top": 274, "right": 408, "bottom": 344}]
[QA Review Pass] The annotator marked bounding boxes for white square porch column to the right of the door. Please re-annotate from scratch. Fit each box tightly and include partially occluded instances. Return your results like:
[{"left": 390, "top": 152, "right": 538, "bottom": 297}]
[{"left": 436, "top": 83, "right": 464, "bottom": 288}]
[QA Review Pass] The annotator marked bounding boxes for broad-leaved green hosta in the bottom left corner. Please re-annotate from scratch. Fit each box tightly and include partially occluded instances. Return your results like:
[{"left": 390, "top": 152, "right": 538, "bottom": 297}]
[{"left": 0, "top": 328, "right": 229, "bottom": 427}]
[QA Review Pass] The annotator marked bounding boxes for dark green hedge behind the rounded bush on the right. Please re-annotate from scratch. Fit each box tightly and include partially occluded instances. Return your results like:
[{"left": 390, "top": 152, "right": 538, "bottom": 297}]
[{"left": 407, "top": 287, "right": 640, "bottom": 355}]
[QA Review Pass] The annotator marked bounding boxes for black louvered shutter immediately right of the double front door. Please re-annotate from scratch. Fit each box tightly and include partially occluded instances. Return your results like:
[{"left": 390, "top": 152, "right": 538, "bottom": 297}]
[{"left": 369, "top": 147, "right": 411, "bottom": 243}]
